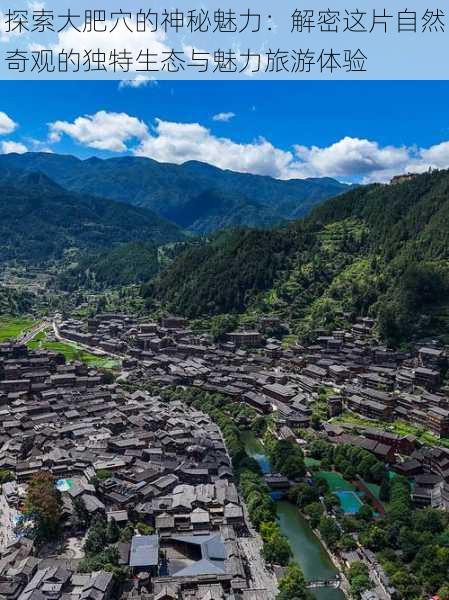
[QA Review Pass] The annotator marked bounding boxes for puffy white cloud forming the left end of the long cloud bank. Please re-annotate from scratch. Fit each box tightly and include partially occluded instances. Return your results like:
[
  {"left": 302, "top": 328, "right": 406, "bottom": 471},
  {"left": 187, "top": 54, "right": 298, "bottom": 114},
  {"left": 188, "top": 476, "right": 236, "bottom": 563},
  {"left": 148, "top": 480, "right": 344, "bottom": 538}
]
[{"left": 49, "top": 110, "right": 148, "bottom": 152}]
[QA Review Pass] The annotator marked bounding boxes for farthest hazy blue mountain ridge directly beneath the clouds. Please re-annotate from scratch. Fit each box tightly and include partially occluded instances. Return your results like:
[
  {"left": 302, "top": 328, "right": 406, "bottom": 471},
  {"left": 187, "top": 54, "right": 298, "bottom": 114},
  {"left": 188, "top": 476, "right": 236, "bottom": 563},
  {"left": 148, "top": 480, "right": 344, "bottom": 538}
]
[{"left": 0, "top": 153, "right": 350, "bottom": 233}]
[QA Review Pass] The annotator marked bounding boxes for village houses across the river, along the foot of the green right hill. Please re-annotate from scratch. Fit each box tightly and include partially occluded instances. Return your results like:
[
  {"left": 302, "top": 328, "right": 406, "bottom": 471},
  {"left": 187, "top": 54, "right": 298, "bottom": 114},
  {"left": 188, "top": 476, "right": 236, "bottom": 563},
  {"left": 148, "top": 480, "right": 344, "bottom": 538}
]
[{"left": 55, "top": 314, "right": 449, "bottom": 510}]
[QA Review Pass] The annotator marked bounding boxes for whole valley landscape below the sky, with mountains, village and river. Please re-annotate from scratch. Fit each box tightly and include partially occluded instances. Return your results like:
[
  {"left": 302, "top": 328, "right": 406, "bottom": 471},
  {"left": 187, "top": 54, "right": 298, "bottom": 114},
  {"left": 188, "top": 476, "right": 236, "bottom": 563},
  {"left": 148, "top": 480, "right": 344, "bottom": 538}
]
[{"left": 0, "top": 153, "right": 449, "bottom": 600}]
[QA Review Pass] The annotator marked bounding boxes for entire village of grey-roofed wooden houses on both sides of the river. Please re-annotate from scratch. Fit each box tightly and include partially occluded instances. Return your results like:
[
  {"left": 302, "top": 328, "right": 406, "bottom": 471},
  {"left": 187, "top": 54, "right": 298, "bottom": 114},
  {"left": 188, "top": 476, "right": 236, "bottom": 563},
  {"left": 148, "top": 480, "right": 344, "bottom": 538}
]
[{"left": 0, "top": 314, "right": 449, "bottom": 600}]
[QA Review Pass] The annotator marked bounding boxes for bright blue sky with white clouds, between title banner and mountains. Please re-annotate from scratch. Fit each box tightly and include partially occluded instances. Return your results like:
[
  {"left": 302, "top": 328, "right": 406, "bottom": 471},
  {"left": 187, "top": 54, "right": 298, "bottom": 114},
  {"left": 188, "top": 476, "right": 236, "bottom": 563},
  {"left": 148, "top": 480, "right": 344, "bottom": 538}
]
[{"left": 0, "top": 81, "right": 449, "bottom": 181}]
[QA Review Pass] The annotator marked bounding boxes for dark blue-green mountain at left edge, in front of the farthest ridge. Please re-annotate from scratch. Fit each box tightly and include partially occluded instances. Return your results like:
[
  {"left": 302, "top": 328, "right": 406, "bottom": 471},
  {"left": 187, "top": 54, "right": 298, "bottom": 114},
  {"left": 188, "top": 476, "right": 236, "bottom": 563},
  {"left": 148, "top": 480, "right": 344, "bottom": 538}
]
[{"left": 0, "top": 165, "right": 185, "bottom": 262}]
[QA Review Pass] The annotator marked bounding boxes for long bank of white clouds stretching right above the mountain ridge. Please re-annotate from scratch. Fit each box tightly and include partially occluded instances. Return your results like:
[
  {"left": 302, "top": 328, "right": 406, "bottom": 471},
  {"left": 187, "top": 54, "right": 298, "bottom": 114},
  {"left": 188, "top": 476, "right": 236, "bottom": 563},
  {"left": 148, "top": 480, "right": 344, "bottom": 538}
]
[{"left": 44, "top": 111, "right": 449, "bottom": 183}]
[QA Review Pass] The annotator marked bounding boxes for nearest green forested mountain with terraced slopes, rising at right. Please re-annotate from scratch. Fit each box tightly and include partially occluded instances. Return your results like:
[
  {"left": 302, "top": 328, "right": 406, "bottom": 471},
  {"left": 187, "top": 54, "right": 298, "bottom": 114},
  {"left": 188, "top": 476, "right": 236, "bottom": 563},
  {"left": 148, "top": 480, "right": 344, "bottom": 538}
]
[{"left": 147, "top": 171, "right": 449, "bottom": 343}]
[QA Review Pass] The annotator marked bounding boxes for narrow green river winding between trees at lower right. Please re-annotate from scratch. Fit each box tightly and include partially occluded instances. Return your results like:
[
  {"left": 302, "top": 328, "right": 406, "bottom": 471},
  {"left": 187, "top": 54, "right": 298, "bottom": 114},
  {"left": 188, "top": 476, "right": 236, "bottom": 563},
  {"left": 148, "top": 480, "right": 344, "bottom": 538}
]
[{"left": 242, "top": 432, "right": 345, "bottom": 600}]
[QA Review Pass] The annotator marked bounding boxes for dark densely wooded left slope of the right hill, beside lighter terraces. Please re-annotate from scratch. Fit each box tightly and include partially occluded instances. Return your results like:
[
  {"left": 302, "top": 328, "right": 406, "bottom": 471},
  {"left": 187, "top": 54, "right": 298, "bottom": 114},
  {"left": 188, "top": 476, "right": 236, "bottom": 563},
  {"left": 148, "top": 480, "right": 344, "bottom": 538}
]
[{"left": 145, "top": 230, "right": 294, "bottom": 317}]
